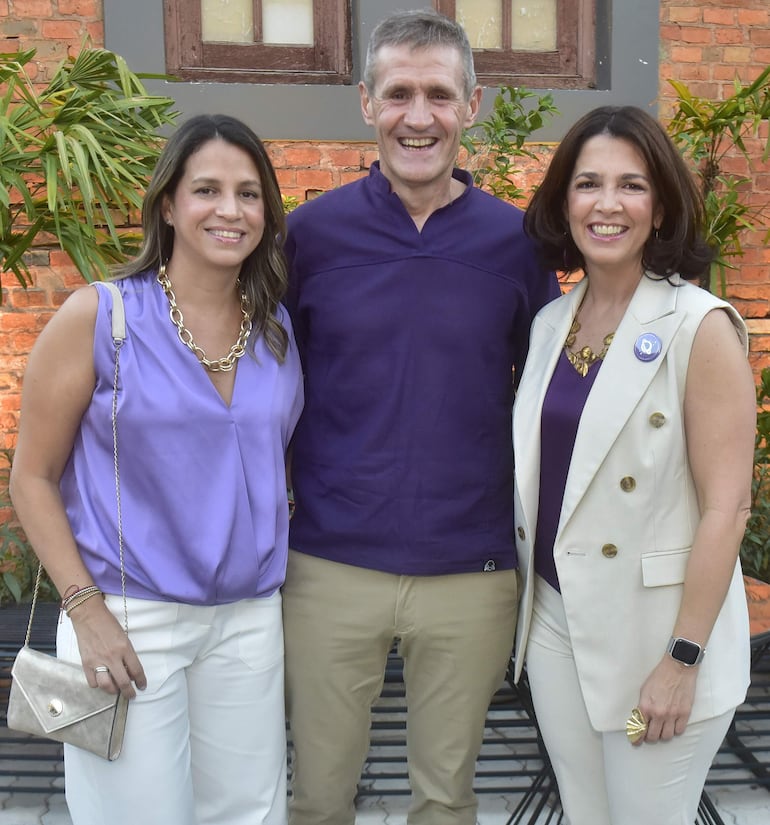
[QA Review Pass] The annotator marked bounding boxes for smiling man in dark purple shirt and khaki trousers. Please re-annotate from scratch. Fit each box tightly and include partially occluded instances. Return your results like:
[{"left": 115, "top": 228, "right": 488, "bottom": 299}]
[{"left": 284, "top": 11, "right": 558, "bottom": 825}]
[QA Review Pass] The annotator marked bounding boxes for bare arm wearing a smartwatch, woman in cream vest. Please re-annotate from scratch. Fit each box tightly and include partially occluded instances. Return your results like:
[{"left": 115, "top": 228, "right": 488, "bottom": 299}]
[{"left": 639, "top": 310, "right": 756, "bottom": 741}]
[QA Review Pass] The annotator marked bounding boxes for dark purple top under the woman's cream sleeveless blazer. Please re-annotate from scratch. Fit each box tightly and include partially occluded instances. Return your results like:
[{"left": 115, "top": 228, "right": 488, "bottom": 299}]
[{"left": 535, "top": 350, "right": 602, "bottom": 590}]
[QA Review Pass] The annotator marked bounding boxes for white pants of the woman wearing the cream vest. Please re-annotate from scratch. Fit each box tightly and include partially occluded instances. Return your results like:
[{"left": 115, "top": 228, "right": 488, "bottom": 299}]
[{"left": 526, "top": 577, "right": 734, "bottom": 825}]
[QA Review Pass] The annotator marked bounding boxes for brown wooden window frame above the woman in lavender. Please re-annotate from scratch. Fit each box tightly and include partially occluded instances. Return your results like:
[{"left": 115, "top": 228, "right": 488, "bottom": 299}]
[{"left": 163, "top": 0, "right": 352, "bottom": 85}]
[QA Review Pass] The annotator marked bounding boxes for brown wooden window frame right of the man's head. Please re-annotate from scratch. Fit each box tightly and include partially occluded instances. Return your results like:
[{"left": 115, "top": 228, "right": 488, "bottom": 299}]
[{"left": 434, "top": 0, "right": 596, "bottom": 89}]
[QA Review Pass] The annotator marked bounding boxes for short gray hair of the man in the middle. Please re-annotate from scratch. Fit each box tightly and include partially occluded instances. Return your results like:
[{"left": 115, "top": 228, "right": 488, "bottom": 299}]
[{"left": 364, "top": 10, "right": 476, "bottom": 100}]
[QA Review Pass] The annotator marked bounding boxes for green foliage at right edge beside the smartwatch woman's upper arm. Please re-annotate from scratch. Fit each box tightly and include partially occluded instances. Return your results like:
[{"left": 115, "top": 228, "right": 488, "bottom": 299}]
[{"left": 741, "top": 367, "right": 770, "bottom": 582}]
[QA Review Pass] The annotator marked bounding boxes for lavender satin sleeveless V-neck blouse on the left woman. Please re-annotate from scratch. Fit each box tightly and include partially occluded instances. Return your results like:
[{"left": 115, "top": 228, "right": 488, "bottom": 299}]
[{"left": 61, "top": 272, "right": 302, "bottom": 605}]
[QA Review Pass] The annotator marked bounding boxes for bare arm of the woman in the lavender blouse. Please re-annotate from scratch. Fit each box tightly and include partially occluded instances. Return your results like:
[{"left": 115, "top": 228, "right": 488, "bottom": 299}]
[{"left": 10, "top": 287, "right": 145, "bottom": 697}]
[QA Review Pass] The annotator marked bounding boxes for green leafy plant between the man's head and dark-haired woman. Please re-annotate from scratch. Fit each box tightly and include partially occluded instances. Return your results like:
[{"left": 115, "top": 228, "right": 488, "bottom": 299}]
[{"left": 462, "top": 86, "right": 559, "bottom": 203}]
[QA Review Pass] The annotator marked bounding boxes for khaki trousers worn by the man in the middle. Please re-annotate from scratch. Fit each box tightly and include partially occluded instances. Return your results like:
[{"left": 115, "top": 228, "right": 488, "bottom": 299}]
[{"left": 283, "top": 551, "right": 518, "bottom": 825}]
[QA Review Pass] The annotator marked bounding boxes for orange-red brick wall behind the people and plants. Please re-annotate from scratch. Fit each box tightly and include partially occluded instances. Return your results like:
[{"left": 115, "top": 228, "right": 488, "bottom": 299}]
[{"left": 0, "top": 0, "right": 770, "bottom": 448}]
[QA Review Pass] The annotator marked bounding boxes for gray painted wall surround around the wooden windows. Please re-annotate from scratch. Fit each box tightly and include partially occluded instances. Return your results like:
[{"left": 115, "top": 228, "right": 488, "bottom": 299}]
[{"left": 104, "top": 0, "right": 659, "bottom": 140}]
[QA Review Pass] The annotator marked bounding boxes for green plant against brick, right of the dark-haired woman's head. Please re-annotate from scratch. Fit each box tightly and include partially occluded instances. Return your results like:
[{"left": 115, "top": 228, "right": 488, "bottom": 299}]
[{"left": 668, "top": 66, "right": 770, "bottom": 296}]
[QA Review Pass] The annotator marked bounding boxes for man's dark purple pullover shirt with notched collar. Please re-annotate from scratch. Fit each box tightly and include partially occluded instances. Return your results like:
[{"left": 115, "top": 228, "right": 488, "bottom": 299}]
[{"left": 287, "top": 164, "right": 559, "bottom": 575}]
